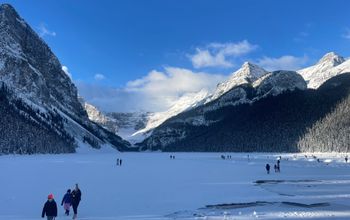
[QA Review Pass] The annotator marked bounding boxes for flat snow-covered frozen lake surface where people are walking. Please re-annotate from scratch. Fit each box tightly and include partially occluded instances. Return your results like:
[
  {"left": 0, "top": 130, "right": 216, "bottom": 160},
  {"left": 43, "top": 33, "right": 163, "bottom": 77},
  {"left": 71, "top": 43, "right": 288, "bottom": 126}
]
[{"left": 0, "top": 152, "right": 350, "bottom": 220}]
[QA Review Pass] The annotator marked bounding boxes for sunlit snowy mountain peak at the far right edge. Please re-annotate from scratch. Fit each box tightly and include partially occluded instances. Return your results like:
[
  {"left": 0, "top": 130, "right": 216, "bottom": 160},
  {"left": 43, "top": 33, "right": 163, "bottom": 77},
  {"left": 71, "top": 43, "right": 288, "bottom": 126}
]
[{"left": 298, "top": 52, "right": 350, "bottom": 89}]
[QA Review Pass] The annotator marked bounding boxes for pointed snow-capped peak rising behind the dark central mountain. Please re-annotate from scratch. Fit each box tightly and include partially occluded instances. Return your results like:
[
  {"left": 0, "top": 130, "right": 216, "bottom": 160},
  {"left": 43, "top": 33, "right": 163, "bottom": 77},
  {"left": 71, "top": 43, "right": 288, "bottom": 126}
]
[{"left": 207, "top": 62, "right": 267, "bottom": 102}]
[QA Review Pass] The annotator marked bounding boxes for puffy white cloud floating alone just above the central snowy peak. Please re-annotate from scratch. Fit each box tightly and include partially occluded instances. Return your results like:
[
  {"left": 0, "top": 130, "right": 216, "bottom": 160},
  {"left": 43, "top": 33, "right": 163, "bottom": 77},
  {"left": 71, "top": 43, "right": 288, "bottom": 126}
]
[{"left": 188, "top": 40, "right": 258, "bottom": 69}]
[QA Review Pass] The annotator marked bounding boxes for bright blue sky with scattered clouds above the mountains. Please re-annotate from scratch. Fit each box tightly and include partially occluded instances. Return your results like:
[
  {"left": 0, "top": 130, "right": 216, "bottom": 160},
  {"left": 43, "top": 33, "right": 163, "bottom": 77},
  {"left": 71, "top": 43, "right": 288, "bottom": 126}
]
[{"left": 6, "top": 0, "right": 350, "bottom": 111}]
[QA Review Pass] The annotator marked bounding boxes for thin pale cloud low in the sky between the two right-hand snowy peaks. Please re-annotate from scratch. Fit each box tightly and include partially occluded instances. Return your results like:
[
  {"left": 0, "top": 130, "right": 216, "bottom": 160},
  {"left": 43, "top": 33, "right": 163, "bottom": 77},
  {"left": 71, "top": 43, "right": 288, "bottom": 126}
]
[{"left": 257, "top": 55, "right": 308, "bottom": 71}]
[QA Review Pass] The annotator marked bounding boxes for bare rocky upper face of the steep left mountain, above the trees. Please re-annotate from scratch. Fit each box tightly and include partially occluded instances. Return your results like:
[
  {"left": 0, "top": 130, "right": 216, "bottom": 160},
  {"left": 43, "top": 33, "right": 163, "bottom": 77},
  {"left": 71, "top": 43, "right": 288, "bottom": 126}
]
[{"left": 0, "top": 4, "right": 87, "bottom": 118}]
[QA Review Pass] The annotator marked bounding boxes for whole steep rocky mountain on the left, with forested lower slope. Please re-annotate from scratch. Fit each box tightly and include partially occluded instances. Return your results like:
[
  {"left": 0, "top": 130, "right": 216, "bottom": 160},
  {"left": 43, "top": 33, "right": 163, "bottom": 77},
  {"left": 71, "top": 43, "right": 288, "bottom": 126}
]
[{"left": 0, "top": 4, "right": 130, "bottom": 153}]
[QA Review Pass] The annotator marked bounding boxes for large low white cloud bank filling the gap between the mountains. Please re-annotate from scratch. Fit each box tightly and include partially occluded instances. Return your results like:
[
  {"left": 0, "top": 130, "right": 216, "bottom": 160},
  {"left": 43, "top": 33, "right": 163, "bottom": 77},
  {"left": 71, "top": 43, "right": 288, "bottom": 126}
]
[{"left": 77, "top": 67, "right": 226, "bottom": 112}]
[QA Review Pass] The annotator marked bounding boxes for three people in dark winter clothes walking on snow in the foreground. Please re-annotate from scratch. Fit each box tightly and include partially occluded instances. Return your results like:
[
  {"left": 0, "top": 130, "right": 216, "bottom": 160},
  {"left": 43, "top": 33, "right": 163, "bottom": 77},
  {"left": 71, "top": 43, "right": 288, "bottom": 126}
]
[{"left": 41, "top": 184, "right": 81, "bottom": 220}]
